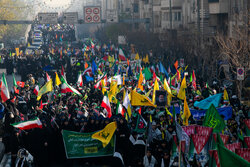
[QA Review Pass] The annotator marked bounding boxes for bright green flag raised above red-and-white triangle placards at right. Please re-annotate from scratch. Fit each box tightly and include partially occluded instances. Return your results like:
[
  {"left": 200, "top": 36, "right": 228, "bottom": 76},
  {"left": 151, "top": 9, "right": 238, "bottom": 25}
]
[{"left": 203, "top": 104, "right": 226, "bottom": 132}]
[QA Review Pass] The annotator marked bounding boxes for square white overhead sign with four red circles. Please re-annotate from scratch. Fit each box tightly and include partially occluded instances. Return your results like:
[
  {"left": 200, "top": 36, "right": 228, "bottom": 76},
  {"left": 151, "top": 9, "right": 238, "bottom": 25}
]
[{"left": 84, "top": 6, "right": 101, "bottom": 23}]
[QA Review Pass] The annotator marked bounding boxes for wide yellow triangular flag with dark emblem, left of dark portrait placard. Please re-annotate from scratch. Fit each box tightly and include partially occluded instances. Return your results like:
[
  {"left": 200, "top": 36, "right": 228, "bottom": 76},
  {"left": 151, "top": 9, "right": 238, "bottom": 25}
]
[{"left": 131, "top": 90, "right": 156, "bottom": 107}]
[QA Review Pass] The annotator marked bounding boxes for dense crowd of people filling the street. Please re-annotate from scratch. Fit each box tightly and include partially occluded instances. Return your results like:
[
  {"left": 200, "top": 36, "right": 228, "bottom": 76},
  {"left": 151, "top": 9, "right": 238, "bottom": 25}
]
[{"left": 1, "top": 23, "right": 249, "bottom": 167}]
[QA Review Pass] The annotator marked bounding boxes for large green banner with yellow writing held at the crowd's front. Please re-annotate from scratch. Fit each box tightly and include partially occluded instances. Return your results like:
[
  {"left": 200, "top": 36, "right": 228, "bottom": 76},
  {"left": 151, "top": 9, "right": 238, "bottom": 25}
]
[{"left": 62, "top": 130, "right": 115, "bottom": 159}]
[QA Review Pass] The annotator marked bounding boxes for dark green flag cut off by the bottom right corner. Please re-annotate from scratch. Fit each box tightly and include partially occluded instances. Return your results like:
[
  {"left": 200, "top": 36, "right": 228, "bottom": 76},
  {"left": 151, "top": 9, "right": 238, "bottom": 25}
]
[{"left": 217, "top": 142, "right": 250, "bottom": 167}]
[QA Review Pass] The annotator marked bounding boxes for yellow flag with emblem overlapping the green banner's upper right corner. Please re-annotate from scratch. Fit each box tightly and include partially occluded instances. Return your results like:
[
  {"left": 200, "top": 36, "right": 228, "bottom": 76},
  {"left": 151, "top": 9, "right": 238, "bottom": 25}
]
[{"left": 91, "top": 122, "right": 117, "bottom": 148}]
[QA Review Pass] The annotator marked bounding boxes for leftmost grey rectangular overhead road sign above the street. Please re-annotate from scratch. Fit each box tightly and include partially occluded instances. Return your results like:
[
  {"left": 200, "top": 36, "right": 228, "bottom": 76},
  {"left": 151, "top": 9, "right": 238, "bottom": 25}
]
[{"left": 38, "top": 13, "right": 58, "bottom": 24}]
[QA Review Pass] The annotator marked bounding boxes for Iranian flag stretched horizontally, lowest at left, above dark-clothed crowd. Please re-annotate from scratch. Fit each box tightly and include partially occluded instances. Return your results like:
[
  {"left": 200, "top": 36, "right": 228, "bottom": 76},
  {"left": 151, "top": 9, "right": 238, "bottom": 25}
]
[{"left": 11, "top": 118, "right": 42, "bottom": 130}]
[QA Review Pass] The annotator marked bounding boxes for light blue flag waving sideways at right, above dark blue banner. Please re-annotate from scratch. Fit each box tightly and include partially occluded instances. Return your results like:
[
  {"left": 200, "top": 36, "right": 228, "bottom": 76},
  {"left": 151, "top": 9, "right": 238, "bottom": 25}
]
[{"left": 194, "top": 93, "right": 222, "bottom": 110}]
